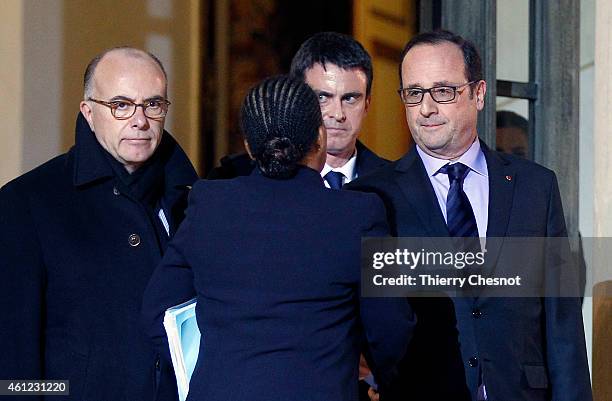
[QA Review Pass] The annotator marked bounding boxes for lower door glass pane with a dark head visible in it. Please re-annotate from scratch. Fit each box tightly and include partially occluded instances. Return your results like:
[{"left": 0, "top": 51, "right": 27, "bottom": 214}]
[{"left": 495, "top": 96, "right": 533, "bottom": 159}]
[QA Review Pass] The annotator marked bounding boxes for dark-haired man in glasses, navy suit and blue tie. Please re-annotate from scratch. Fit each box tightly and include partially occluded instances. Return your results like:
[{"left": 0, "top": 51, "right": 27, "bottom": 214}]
[{"left": 348, "top": 31, "right": 592, "bottom": 401}]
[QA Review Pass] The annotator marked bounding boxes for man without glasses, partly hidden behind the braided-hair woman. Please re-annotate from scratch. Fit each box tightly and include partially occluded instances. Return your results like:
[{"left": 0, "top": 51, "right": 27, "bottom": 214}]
[{"left": 208, "top": 32, "right": 387, "bottom": 184}]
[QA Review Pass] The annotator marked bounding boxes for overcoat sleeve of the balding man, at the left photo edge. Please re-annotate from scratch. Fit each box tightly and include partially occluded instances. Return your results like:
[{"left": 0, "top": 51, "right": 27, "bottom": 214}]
[{"left": 0, "top": 184, "right": 46, "bottom": 399}]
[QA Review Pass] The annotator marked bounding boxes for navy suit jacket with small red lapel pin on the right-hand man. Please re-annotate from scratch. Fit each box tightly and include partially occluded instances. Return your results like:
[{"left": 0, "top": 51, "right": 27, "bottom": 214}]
[{"left": 347, "top": 142, "right": 591, "bottom": 401}]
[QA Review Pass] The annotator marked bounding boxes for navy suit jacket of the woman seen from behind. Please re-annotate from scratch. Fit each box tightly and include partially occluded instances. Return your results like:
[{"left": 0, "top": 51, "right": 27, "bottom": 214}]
[{"left": 143, "top": 167, "right": 414, "bottom": 401}]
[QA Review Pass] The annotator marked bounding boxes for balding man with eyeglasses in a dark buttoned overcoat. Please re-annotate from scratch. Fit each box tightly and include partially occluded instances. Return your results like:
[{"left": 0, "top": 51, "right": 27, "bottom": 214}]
[{"left": 0, "top": 47, "right": 197, "bottom": 401}]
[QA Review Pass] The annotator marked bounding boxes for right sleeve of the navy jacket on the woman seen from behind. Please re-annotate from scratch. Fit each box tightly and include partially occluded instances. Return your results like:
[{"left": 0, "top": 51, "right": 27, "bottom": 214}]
[{"left": 360, "top": 195, "right": 416, "bottom": 396}]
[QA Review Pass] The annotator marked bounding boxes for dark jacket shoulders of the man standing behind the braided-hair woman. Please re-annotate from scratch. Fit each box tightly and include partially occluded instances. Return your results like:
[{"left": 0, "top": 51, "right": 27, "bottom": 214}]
[{"left": 206, "top": 141, "right": 389, "bottom": 180}]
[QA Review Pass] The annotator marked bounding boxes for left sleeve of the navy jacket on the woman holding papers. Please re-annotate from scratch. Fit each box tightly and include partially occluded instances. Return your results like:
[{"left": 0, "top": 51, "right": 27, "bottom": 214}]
[{"left": 141, "top": 187, "right": 199, "bottom": 361}]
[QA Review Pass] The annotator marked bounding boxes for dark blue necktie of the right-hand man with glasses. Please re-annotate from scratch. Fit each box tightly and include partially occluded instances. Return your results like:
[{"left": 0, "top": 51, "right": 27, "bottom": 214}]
[{"left": 439, "top": 163, "right": 478, "bottom": 237}]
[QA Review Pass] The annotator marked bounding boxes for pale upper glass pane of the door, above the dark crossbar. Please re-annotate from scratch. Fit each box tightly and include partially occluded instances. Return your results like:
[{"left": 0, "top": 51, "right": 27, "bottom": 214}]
[{"left": 496, "top": 0, "right": 530, "bottom": 82}]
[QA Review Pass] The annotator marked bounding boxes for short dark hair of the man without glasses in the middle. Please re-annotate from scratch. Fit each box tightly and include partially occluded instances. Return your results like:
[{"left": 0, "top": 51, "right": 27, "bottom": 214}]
[{"left": 290, "top": 32, "right": 374, "bottom": 96}]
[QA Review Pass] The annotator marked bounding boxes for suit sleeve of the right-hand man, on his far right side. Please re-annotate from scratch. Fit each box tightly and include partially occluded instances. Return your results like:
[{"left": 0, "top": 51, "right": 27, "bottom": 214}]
[{"left": 544, "top": 176, "right": 593, "bottom": 401}]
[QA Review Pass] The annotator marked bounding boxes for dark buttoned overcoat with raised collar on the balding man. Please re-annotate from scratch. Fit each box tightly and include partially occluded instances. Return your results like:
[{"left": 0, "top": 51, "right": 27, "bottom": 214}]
[{"left": 0, "top": 115, "right": 197, "bottom": 401}]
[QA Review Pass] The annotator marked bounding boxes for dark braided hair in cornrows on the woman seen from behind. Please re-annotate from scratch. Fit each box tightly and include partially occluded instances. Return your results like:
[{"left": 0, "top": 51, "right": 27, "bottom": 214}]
[{"left": 240, "top": 75, "right": 323, "bottom": 178}]
